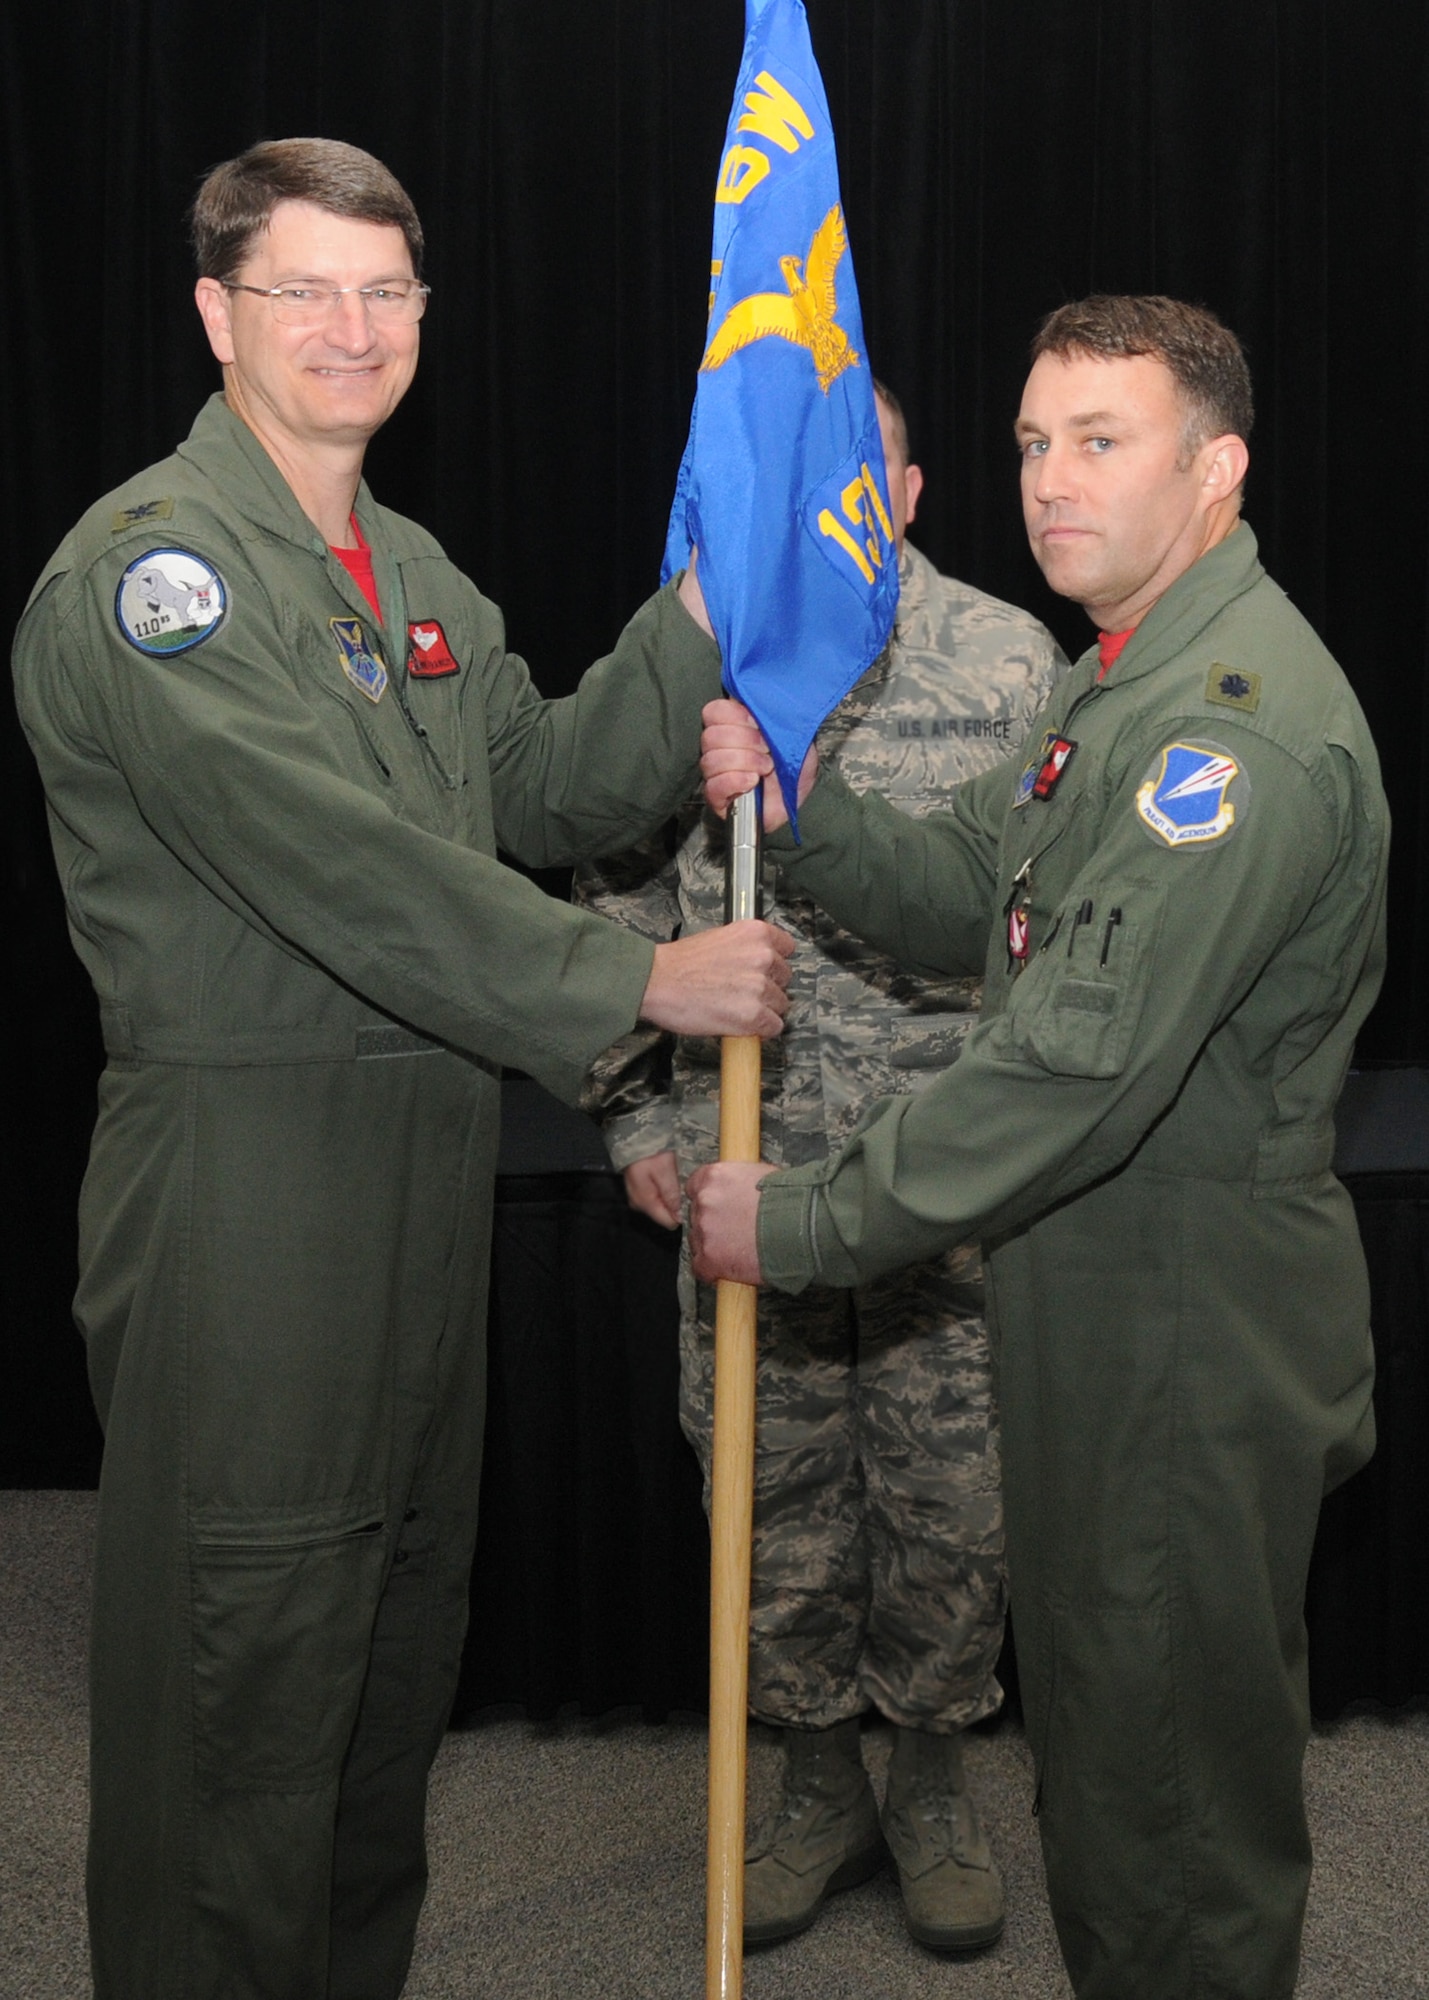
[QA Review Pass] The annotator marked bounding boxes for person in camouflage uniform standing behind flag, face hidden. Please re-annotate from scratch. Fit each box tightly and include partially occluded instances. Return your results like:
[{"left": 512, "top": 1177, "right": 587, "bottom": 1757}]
[{"left": 576, "top": 390, "right": 1061, "bottom": 1948}]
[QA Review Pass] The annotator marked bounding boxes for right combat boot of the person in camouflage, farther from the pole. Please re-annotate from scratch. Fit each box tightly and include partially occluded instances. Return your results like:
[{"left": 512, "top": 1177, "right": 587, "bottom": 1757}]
[{"left": 883, "top": 1728, "right": 1003, "bottom": 1952}]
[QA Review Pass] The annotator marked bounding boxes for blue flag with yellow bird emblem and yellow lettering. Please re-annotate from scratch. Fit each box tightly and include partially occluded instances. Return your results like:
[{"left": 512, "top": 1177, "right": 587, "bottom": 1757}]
[{"left": 664, "top": 0, "right": 899, "bottom": 832}]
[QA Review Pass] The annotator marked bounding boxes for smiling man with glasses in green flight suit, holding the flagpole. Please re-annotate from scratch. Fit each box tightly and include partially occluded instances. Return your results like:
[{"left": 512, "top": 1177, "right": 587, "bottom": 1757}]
[{"left": 16, "top": 140, "right": 791, "bottom": 2000}]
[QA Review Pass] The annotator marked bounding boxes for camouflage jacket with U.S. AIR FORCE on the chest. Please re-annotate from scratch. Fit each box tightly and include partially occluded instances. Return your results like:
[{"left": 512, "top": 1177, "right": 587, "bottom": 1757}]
[{"left": 574, "top": 544, "right": 1065, "bottom": 1168}]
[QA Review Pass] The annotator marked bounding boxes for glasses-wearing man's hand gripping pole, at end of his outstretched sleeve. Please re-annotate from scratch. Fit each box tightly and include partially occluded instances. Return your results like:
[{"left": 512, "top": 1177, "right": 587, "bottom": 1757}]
[{"left": 640, "top": 918, "right": 795, "bottom": 1042}]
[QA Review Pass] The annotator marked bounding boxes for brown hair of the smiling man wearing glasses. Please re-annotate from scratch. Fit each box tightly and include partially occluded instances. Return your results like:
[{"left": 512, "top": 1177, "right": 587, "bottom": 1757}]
[{"left": 188, "top": 138, "right": 422, "bottom": 280}]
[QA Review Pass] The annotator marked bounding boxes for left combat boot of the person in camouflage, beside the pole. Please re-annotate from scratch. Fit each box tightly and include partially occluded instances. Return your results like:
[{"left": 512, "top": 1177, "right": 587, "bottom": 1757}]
[{"left": 745, "top": 1720, "right": 887, "bottom": 1944}]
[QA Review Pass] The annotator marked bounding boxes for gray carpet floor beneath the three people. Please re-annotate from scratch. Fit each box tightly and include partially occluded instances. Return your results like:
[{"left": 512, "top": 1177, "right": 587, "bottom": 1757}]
[{"left": 0, "top": 1492, "right": 1429, "bottom": 2000}]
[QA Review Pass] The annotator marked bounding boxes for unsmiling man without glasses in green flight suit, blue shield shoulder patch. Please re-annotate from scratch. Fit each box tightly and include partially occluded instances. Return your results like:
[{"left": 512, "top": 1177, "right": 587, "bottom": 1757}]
[{"left": 690, "top": 298, "right": 1387, "bottom": 2000}]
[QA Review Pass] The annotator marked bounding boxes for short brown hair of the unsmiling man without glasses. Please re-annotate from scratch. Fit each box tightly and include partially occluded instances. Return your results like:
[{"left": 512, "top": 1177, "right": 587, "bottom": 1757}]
[{"left": 1033, "top": 292, "right": 1255, "bottom": 456}]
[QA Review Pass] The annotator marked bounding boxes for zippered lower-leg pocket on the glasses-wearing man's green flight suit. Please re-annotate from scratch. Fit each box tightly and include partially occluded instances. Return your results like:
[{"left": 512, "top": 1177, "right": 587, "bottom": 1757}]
[{"left": 190, "top": 1504, "right": 386, "bottom": 1792}]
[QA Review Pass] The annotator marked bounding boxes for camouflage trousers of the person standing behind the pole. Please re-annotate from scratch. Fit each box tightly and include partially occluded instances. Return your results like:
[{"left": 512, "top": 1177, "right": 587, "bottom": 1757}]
[{"left": 680, "top": 1250, "right": 1007, "bottom": 1732}]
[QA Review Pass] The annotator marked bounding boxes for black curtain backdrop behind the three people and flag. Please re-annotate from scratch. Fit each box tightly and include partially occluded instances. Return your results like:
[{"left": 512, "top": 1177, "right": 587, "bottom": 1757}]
[{"left": 0, "top": 0, "right": 1429, "bottom": 1484}]
